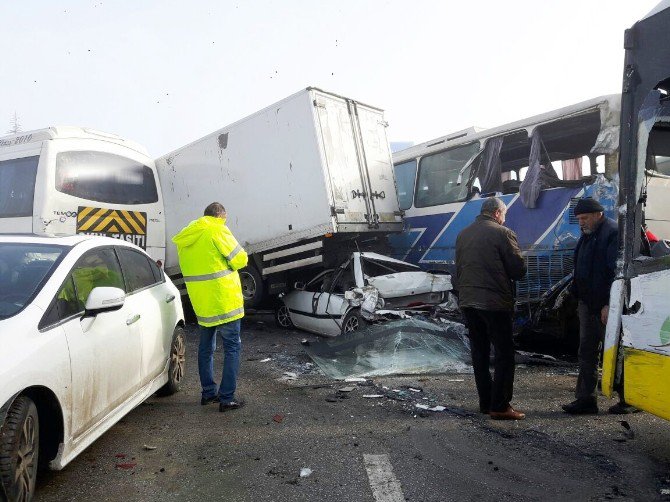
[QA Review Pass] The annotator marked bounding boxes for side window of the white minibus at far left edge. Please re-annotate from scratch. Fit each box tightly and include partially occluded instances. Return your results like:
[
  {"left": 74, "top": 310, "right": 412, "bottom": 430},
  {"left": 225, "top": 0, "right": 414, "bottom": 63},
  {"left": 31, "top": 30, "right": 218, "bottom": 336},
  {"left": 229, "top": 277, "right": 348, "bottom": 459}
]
[{"left": 0, "top": 157, "right": 39, "bottom": 218}]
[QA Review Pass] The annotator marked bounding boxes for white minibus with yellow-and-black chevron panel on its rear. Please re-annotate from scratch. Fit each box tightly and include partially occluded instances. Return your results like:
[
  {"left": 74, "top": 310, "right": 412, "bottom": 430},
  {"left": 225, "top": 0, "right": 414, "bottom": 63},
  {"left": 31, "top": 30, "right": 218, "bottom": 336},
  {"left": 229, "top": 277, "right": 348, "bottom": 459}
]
[{"left": 0, "top": 127, "right": 165, "bottom": 262}]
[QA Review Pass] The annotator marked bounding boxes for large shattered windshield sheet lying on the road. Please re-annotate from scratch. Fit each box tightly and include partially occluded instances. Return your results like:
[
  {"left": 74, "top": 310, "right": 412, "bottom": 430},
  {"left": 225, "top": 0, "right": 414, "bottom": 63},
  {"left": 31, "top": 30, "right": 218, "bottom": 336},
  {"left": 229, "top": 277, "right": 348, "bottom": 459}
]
[{"left": 305, "top": 317, "right": 472, "bottom": 379}]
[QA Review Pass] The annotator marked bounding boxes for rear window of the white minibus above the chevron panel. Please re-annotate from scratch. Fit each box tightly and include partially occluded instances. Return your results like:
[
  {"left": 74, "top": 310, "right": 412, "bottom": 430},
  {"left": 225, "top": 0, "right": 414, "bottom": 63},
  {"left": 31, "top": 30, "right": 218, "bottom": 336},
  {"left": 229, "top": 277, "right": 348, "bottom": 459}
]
[{"left": 56, "top": 151, "right": 158, "bottom": 204}]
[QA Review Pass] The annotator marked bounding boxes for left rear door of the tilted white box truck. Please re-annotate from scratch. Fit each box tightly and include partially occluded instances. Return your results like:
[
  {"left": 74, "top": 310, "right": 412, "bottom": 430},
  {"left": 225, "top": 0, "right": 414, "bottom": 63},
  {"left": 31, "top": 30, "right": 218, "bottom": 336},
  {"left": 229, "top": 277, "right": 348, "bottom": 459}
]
[{"left": 314, "top": 92, "right": 372, "bottom": 224}]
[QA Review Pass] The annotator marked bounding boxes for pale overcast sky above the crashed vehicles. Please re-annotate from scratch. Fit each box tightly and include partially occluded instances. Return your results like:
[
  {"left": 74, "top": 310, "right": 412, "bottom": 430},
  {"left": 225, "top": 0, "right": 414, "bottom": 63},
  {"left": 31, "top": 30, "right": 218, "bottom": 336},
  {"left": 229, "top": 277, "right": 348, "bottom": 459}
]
[{"left": 0, "top": 0, "right": 658, "bottom": 157}]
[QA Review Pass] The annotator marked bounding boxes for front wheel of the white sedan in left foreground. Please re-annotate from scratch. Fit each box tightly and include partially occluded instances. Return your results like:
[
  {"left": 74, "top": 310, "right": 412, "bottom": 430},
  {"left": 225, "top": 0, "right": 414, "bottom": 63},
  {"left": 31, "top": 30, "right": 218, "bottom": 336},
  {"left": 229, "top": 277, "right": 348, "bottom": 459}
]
[{"left": 0, "top": 396, "right": 40, "bottom": 501}]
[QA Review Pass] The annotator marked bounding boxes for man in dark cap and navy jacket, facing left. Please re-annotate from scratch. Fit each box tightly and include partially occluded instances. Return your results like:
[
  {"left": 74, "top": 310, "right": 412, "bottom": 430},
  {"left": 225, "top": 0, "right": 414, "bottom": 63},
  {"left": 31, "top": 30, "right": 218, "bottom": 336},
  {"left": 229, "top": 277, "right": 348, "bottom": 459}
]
[{"left": 563, "top": 198, "right": 618, "bottom": 415}]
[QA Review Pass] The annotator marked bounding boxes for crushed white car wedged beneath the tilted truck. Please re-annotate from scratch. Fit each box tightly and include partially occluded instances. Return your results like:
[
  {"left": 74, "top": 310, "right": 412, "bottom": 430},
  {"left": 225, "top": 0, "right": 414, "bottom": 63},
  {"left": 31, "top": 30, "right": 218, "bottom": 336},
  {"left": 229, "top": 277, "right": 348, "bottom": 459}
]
[{"left": 275, "top": 253, "right": 452, "bottom": 336}]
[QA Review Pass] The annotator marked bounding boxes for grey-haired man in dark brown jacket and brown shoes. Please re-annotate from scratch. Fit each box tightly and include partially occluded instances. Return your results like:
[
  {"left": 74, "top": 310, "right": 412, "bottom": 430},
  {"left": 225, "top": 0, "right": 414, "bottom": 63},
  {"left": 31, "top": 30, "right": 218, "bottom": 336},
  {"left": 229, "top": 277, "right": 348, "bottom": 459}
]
[{"left": 456, "top": 197, "right": 526, "bottom": 420}]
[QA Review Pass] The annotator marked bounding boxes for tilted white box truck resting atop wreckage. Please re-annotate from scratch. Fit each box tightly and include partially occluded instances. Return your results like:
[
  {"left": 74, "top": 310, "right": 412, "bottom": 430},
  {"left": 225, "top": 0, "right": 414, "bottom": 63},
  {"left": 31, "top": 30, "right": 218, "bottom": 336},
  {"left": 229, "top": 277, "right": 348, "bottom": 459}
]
[{"left": 156, "top": 88, "right": 402, "bottom": 305}]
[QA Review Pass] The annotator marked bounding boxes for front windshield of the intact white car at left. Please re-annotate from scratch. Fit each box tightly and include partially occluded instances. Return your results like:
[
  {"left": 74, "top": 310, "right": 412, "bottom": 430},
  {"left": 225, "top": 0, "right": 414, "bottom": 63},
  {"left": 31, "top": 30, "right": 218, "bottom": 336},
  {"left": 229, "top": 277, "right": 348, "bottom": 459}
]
[{"left": 0, "top": 242, "right": 67, "bottom": 319}]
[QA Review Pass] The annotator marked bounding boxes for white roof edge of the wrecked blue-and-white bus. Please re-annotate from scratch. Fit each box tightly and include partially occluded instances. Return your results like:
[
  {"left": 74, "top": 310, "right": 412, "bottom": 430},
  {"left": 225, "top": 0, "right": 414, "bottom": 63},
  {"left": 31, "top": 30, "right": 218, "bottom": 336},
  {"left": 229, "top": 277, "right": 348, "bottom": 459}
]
[{"left": 393, "top": 94, "right": 620, "bottom": 163}]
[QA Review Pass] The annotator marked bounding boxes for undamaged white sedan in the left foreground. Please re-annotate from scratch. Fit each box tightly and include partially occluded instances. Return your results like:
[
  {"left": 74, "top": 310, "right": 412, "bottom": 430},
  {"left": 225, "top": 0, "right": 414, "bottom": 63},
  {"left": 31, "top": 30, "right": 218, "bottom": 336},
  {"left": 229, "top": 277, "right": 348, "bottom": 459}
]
[{"left": 0, "top": 235, "right": 185, "bottom": 500}]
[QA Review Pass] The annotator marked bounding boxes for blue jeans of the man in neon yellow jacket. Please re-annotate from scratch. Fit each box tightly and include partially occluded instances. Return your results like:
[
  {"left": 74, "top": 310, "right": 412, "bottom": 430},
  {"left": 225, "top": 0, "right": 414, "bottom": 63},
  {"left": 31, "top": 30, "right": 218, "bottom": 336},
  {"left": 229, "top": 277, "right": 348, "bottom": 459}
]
[{"left": 198, "top": 319, "right": 242, "bottom": 403}]
